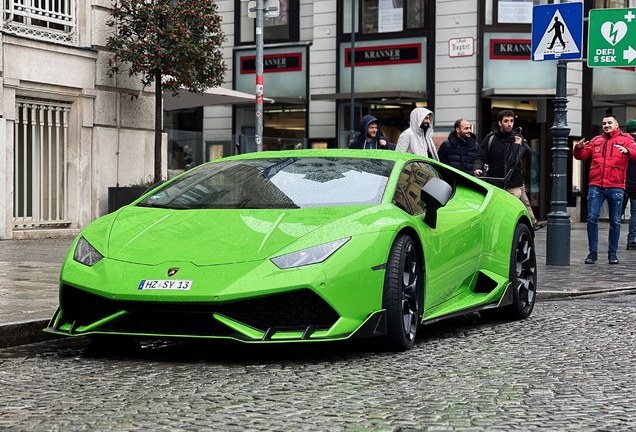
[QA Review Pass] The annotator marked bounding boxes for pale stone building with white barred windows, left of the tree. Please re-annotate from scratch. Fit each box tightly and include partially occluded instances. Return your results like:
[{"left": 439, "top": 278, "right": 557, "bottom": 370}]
[{"left": 0, "top": 0, "right": 154, "bottom": 239}]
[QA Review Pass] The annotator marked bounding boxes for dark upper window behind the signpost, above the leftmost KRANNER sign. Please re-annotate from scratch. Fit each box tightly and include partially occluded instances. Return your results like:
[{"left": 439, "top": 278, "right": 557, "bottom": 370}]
[{"left": 235, "top": 0, "right": 300, "bottom": 44}]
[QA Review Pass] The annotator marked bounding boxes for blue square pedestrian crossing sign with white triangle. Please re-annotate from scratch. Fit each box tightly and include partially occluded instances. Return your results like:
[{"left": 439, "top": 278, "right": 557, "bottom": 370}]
[{"left": 532, "top": 2, "right": 583, "bottom": 61}]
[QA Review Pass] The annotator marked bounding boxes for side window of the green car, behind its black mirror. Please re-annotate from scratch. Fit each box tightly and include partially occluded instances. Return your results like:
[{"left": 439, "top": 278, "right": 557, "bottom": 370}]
[{"left": 393, "top": 162, "right": 441, "bottom": 216}]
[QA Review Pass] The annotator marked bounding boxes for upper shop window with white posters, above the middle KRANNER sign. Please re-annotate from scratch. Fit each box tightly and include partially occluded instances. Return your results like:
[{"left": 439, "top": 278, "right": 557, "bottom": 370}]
[{"left": 340, "top": 0, "right": 426, "bottom": 34}]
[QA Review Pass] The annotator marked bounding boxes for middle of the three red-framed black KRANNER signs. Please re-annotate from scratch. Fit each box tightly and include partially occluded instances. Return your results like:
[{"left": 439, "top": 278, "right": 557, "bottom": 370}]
[{"left": 345, "top": 44, "right": 422, "bottom": 67}]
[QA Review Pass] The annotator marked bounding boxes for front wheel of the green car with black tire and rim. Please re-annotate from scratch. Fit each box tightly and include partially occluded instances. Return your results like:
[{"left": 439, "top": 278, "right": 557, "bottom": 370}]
[{"left": 382, "top": 234, "right": 423, "bottom": 351}]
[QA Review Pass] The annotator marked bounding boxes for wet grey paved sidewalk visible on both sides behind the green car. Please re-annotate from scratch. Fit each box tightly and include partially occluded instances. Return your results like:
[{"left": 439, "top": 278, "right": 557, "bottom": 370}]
[{"left": 0, "top": 222, "right": 636, "bottom": 347}]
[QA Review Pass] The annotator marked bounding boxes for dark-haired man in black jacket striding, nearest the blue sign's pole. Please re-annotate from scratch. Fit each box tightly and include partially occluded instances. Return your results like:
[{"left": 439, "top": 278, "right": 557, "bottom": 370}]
[{"left": 473, "top": 110, "right": 547, "bottom": 230}]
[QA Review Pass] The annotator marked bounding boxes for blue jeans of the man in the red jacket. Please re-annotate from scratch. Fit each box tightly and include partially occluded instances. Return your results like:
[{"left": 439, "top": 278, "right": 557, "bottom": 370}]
[{"left": 587, "top": 186, "right": 623, "bottom": 255}]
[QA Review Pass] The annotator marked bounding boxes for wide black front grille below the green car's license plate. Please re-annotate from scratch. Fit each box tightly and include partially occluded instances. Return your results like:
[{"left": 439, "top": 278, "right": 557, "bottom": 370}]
[{"left": 60, "top": 285, "right": 339, "bottom": 334}]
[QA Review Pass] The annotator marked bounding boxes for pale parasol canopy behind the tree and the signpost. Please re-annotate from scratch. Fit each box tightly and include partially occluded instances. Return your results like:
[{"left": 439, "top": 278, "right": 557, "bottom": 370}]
[{"left": 163, "top": 87, "right": 274, "bottom": 111}]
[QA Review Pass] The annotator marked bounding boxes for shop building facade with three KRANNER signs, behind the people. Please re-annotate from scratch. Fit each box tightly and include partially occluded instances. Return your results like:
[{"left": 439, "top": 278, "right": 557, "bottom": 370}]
[{"left": 193, "top": 0, "right": 636, "bottom": 224}]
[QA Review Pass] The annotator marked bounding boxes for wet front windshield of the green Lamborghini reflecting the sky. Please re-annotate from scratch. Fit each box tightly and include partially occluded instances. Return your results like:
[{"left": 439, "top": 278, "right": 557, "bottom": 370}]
[{"left": 137, "top": 157, "right": 394, "bottom": 209}]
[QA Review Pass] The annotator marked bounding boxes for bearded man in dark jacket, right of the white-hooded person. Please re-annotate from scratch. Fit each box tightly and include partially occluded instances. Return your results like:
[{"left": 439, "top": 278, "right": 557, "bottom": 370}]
[{"left": 437, "top": 119, "right": 479, "bottom": 175}]
